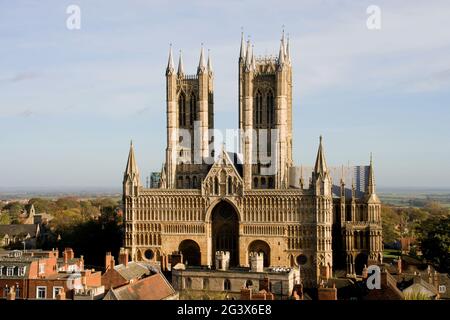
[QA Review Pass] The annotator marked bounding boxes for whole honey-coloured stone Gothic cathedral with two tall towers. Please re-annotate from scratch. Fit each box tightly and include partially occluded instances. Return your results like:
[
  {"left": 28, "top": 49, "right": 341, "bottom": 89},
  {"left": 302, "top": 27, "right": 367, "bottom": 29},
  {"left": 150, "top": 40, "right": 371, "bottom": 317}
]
[{"left": 123, "top": 33, "right": 383, "bottom": 287}]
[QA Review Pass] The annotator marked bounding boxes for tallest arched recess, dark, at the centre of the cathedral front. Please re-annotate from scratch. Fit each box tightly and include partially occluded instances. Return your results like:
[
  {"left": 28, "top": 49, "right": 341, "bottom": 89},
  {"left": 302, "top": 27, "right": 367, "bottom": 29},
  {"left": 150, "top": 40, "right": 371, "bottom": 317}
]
[{"left": 211, "top": 201, "right": 239, "bottom": 266}]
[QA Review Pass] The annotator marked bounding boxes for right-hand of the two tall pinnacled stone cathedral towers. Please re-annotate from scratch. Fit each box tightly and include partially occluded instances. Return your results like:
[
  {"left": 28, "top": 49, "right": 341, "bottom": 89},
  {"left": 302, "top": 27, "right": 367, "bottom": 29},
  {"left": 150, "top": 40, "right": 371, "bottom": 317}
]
[{"left": 239, "top": 31, "right": 292, "bottom": 189}]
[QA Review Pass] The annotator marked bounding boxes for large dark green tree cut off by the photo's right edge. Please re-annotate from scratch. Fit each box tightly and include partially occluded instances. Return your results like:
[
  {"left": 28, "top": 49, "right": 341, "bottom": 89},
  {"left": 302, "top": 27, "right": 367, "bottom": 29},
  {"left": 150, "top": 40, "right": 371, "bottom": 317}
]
[{"left": 418, "top": 215, "right": 450, "bottom": 273}]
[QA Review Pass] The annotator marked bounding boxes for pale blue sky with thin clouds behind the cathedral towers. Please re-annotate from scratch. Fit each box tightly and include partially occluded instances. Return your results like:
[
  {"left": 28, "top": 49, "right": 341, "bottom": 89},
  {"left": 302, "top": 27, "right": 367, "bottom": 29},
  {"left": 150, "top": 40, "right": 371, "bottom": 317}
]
[{"left": 0, "top": 0, "right": 450, "bottom": 189}]
